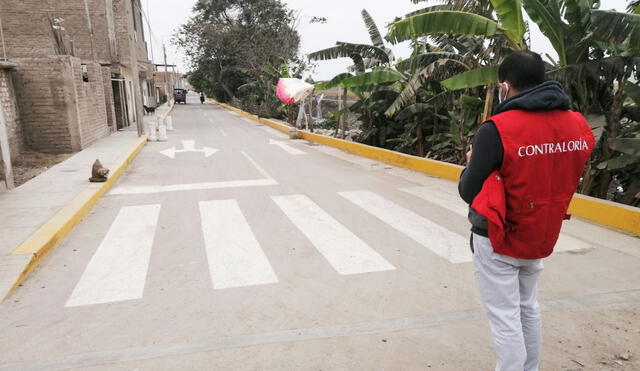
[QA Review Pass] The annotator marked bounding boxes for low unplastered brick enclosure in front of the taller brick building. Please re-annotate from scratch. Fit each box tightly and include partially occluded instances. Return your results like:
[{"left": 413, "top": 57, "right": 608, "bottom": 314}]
[{"left": 12, "top": 56, "right": 109, "bottom": 153}]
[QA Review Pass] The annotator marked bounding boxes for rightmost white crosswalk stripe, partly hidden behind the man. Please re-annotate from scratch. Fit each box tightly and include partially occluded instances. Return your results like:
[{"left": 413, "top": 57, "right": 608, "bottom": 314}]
[{"left": 401, "top": 187, "right": 593, "bottom": 251}]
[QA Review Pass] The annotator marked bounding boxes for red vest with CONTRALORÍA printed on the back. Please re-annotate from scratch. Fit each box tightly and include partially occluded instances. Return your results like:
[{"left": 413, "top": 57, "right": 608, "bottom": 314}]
[{"left": 471, "top": 110, "right": 595, "bottom": 259}]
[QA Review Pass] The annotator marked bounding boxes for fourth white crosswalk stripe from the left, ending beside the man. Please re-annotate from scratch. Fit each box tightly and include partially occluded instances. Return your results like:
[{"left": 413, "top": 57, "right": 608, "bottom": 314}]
[{"left": 339, "top": 191, "right": 471, "bottom": 263}]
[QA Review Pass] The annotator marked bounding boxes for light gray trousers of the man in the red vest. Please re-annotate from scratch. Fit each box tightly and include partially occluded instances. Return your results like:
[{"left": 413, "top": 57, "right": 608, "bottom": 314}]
[{"left": 472, "top": 233, "right": 543, "bottom": 371}]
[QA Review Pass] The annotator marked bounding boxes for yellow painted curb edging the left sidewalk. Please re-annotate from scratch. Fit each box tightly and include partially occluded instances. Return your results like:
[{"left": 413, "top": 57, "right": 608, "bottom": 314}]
[{"left": 7, "top": 135, "right": 147, "bottom": 296}]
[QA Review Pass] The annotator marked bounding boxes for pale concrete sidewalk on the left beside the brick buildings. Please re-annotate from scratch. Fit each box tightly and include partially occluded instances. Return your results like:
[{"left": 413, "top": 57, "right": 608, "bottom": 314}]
[{"left": 0, "top": 129, "right": 146, "bottom": 301}]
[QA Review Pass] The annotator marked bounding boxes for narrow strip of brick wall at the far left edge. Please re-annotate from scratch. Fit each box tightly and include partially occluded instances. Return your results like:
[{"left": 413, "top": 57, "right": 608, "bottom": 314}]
[{"left": 0, "top": 66, "right": 22, "bottom": 159}]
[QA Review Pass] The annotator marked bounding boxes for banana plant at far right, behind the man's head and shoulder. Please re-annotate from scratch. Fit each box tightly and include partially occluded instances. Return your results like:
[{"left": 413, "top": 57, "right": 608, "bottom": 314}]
[{"left": 522, "top": 0, "right": 640, "bottom": 201}]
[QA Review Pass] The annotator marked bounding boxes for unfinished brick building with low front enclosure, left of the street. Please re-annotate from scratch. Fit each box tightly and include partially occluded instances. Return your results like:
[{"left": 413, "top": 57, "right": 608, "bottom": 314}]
[{"left": 0, "top": 0, "right": 156, "bottom": 158}]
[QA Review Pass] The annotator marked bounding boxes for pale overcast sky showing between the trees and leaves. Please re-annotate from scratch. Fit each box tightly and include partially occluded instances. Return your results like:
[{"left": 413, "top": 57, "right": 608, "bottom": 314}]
[{"left": 142, "top": 0, "right": 628, "bottom": 80}]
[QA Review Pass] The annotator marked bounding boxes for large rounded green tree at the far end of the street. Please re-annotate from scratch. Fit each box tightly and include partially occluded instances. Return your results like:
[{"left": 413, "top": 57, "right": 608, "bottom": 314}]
[{"left": 174, "top": 0, "right": 300, "bottom": 114}]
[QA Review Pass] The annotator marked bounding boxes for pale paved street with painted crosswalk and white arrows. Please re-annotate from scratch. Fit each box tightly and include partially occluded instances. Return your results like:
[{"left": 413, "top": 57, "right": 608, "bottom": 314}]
[{"left": 0, "top": 96, "right": 640, "bottom": 370}]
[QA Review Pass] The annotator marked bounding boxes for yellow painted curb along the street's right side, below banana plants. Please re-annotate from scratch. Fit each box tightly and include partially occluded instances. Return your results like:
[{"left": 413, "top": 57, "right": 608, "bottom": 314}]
[{"left": 210, "top": 99, "right": 640, "bottom": 236}]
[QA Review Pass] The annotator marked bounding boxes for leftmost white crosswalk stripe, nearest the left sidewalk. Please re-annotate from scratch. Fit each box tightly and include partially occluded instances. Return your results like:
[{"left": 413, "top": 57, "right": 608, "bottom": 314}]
[{"left": 66, "top": 205, "right": 160, "bottom": 307}]
